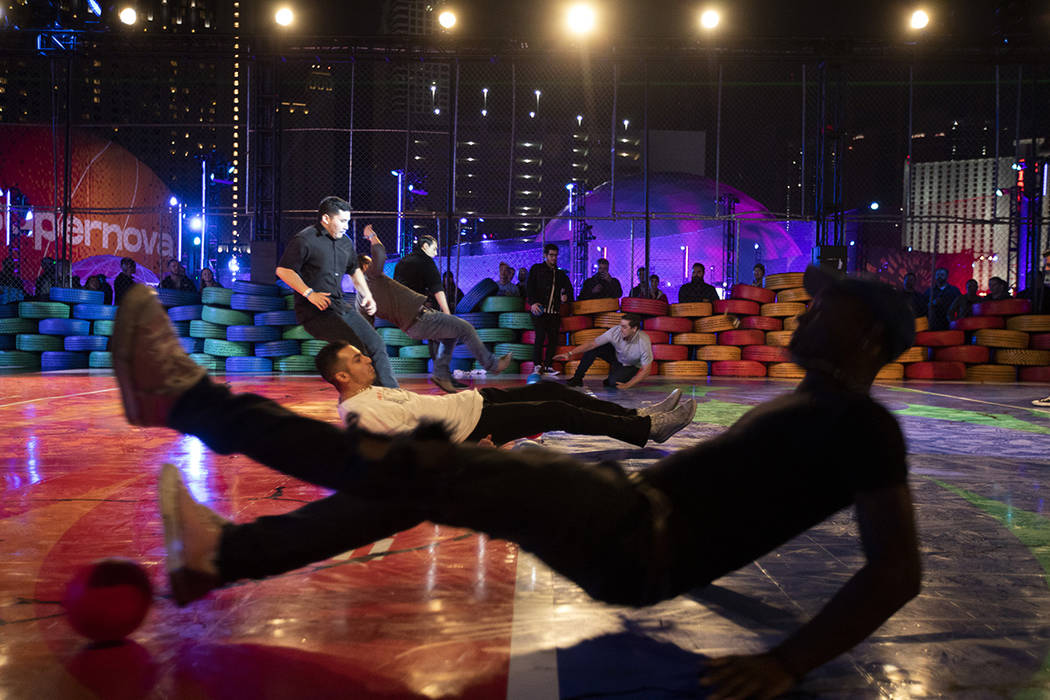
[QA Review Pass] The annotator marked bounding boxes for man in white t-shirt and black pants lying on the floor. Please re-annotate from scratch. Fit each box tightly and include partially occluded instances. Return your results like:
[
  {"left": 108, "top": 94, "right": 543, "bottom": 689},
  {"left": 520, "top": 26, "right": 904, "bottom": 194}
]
[{"left": 317, "top": 342, "right": 696, "bottom": 447}]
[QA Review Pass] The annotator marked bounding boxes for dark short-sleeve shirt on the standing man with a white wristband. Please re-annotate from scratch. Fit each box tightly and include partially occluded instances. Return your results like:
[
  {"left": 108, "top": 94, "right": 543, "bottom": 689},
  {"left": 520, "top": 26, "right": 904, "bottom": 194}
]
[{"left": 277, "top": 224, "right": 357, "bottom": 312}]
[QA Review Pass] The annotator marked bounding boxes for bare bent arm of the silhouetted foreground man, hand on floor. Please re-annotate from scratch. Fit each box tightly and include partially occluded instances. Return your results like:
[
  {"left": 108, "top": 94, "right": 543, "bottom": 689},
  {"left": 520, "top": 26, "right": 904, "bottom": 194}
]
[{"left": 704, "top": 485, "right": 922, "bottom": 698}]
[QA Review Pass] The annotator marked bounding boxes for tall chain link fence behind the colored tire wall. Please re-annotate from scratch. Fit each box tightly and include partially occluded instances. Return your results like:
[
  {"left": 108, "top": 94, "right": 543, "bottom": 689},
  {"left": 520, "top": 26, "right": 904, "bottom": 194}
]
[{"left": 0, "top": 43, "right": 1050, "bottom": 308}]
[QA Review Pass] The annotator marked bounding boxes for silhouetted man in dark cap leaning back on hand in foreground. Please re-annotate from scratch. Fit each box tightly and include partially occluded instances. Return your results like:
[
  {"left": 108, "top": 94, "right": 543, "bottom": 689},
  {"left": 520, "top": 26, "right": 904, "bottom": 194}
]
[{"left": 113, "top": 268, "right": 921, "bottom": 698}]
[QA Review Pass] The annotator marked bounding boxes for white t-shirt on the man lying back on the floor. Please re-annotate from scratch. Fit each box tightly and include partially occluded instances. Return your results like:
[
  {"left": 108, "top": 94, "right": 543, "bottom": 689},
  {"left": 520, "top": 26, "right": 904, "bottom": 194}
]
[{"left": 339, "top": 386, "right": 483, "bottom": 443}]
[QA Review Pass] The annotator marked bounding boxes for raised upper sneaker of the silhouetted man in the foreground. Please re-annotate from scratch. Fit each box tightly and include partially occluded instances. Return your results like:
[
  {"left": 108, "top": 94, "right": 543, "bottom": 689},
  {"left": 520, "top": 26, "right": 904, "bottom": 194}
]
[{"left": 111, "top": 284, "right": 208, "bottom": 425}]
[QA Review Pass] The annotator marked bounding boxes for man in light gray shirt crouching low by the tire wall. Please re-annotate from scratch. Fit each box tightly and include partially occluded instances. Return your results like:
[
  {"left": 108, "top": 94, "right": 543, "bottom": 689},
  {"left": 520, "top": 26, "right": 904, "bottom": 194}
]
[{"left": 554, "top": 314, "right": 653, "bottom": 389}]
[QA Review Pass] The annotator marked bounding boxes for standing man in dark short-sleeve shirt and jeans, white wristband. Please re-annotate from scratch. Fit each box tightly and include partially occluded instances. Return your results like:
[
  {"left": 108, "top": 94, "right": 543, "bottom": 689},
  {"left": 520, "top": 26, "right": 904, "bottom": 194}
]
[{"left": 276, "top": 197, "right": 398, "bottom": 388}]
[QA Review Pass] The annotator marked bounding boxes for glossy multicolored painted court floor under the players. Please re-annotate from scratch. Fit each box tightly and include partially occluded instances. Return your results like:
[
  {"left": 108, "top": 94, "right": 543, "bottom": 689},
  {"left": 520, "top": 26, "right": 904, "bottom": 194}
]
[{"left": 0, "top": 373, "right": 1050, "bottom": 699}]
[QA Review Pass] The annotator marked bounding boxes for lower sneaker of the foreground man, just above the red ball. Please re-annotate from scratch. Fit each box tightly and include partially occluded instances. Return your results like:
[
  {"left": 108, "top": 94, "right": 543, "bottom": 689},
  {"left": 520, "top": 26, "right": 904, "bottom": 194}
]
[{"left": 158, "top": 464, "right": 229, "bottom": 606}]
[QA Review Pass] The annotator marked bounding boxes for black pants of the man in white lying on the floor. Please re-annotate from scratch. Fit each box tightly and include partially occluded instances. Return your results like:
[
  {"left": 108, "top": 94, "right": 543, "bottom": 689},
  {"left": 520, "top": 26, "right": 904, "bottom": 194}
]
[{"left": 467, "top": 382, "right": 652, "bottom": 447}]
